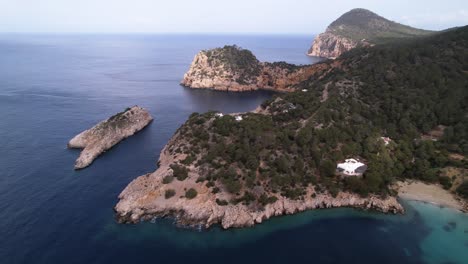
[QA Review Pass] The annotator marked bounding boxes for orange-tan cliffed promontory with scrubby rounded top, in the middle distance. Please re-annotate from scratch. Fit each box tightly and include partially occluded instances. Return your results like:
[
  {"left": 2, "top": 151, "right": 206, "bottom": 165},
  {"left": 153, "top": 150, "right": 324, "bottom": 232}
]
[{"left": 181, "top": 46, "right": 330, "bottom": 92}]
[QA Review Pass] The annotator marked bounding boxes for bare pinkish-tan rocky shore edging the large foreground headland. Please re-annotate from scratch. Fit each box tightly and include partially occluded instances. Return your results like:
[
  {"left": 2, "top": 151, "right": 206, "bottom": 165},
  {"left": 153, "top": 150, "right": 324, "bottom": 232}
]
[{"left": 114, "top": 112, "right": 404, "bottom": 229}]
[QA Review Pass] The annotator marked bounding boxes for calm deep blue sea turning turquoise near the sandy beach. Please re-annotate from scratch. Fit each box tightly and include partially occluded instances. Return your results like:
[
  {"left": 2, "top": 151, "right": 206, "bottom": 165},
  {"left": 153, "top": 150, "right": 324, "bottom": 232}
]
[{"left": 0, "top": 35, "right": 468, "bottom": 264}]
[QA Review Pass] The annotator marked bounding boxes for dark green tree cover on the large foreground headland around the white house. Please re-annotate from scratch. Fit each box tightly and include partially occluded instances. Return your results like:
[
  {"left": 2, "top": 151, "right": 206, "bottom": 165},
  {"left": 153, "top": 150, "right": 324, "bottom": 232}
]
[{"left": 169, "top": 27, "right": 468, "bottom": 206}]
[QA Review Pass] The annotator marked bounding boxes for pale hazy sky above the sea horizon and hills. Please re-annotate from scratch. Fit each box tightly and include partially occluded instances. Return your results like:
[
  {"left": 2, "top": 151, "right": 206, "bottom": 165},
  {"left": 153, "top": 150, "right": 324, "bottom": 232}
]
[{"left": 0, "top": 0, "right": 468, "bottom": 34}]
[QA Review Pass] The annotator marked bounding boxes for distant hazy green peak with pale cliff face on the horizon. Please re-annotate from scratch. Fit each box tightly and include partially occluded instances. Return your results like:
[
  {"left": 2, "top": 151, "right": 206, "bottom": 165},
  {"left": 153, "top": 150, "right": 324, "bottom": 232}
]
[{"left": 307, "top": 8, "right": 434, "bottom": 59}]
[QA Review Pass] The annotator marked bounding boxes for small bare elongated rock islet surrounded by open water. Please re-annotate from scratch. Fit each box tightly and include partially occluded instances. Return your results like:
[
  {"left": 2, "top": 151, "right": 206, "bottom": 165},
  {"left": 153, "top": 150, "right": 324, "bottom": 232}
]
[{"left": 67, "top": 106, "right": 153, "bottom": 169}]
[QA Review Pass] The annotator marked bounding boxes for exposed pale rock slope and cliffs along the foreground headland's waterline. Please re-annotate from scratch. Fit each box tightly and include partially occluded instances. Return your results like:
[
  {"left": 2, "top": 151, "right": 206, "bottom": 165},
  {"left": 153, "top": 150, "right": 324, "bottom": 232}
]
[{"left": 114, "top": 128, "right": 404, "bottom": 229}]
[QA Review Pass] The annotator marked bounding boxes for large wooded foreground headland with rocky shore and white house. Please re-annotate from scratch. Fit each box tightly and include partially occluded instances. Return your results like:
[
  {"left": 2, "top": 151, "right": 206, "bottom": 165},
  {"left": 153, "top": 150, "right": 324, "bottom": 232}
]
[{"left": 115, "top": 27, "right": 468, "bottom": 228}]
